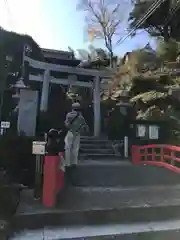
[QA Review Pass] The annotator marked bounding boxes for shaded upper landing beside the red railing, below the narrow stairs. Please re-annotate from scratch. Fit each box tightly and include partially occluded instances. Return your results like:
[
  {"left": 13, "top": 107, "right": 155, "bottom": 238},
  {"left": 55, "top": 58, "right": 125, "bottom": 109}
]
[{"left": 73, "top": 160, "right": 180, "bottom": 187}]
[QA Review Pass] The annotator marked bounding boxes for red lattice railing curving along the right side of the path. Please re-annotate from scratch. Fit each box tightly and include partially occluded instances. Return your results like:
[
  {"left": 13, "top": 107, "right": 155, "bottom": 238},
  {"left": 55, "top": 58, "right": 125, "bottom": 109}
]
[{"left": 132, "top": 144, "right": 180, "bottom": 173}]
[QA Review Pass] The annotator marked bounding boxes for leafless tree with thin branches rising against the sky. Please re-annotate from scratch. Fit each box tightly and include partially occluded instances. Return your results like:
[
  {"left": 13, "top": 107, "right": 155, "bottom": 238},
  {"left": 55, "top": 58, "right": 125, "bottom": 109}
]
[{"left": 78, "top": 0, "right": 129, "bottom": 67}]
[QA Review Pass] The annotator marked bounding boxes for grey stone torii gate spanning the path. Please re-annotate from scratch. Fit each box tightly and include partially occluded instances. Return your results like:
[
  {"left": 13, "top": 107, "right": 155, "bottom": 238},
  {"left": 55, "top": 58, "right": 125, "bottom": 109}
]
[{"left": 25, "top": 57, "right": 112, "bottom": 136}]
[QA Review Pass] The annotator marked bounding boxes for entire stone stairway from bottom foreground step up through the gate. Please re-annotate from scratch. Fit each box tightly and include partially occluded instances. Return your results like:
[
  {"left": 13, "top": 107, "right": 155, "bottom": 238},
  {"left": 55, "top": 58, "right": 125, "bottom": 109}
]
[{"left": 12, "top": 137, "right": 180, "bottom": 240}]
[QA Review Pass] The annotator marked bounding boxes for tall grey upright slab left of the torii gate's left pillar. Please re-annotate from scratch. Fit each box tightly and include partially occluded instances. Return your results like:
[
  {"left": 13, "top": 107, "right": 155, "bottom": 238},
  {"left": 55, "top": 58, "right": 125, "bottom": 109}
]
[{"left": 17, "top": 89, "right": 38, "bottom": 136}]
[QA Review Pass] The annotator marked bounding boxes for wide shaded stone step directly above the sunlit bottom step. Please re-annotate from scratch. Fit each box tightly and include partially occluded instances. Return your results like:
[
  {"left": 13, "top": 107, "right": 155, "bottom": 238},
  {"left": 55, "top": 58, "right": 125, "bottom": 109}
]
[{"left": 12, "top": 185, "right": 180, "bottom": 232}]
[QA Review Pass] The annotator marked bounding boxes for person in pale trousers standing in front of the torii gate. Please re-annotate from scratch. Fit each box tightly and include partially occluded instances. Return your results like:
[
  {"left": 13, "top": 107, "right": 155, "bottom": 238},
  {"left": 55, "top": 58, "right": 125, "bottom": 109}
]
[{"left": 65, "top": 102, "right": 89, "bottom": 183}]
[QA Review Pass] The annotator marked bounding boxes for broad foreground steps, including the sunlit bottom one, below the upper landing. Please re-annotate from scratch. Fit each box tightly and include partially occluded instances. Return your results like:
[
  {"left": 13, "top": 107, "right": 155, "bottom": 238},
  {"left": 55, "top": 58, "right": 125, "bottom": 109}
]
[{"left": 11, "top": 185, "right": 180, "bottom": 240}]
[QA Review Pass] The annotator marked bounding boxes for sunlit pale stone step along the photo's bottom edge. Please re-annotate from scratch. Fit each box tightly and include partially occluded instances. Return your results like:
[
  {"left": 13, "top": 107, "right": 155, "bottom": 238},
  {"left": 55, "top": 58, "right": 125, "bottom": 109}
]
[{"left": 11, "top": 219, "right": 180, "bottom": 240}]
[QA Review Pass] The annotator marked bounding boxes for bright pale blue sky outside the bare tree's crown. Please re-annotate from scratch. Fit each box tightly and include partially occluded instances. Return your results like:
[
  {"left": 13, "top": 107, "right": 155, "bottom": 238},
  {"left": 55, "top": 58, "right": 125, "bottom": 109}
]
[{"left": 0, "top": 0, "right": 155, "bottom": 55}]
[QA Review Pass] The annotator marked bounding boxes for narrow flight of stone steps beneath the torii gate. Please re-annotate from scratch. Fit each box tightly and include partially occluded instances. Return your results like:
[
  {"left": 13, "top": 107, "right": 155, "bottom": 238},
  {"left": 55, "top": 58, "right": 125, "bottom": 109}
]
[{"left": 80, "top": 136, "right": 122, "bottom": 160}]
